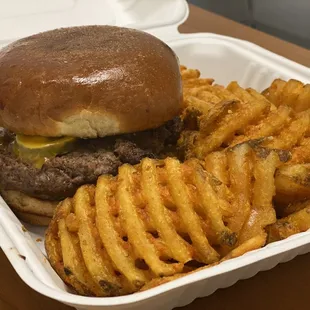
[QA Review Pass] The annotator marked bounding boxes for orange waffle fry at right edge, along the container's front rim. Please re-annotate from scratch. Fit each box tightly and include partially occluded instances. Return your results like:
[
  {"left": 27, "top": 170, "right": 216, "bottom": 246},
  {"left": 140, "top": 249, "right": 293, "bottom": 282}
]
[{"left": 268, "top": 201, "right": 310, "bottom": 243}]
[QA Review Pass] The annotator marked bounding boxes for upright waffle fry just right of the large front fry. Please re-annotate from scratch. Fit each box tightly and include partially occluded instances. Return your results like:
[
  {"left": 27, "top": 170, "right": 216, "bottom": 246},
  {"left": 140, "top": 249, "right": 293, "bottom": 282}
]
[{"left": 205, "top": 141, "right": 289, "bottom": 245}]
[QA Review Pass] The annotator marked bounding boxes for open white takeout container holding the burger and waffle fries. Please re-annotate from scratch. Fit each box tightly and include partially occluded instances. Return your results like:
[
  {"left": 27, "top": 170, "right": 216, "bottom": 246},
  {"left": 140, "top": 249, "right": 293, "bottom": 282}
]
[{"left": 0, "top": 0, "right": 310, "bottom": 310}]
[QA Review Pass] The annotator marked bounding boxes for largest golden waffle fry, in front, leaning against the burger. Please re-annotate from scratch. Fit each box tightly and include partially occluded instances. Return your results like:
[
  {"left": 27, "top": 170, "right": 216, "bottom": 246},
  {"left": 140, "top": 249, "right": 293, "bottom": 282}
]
[{"left": 46, "top": 158, "right": 237, "bottom": 296}]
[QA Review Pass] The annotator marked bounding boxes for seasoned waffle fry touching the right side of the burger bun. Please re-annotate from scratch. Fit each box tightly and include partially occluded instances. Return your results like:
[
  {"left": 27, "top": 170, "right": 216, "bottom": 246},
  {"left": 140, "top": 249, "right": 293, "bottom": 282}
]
[{"left": 179, "top": 82, "right": 271, "bottom": 159}]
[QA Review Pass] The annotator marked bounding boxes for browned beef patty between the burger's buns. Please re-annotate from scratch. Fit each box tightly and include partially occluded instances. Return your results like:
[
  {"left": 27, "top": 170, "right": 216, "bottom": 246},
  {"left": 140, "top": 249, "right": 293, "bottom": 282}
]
[{"left": 0, "top": 118, "right": 182, "bottom": 200}]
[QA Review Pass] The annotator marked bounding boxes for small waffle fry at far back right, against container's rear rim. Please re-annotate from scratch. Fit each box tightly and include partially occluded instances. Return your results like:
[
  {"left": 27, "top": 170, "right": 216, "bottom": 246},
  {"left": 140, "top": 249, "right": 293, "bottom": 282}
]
[{"left": 263, "top": 79, "right": 310, "bottom": 112}]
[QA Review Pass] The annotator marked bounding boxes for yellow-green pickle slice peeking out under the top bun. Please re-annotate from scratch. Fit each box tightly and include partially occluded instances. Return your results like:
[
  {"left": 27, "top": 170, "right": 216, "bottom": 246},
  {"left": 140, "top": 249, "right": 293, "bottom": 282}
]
[{"left": 13, "top": 135, "right": 77, "bottom": 169}]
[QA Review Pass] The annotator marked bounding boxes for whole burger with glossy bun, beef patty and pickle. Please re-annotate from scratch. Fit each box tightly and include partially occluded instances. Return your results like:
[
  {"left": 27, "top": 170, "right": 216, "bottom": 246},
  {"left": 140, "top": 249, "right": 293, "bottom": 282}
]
[{"left": 0, "top": 26, "right": 182, "bottom": 225}]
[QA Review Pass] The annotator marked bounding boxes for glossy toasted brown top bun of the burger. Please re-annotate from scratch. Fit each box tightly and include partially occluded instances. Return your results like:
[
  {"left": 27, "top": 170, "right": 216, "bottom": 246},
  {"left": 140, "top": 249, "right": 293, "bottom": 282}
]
[{"left": 0, "top": 26, "right": 182, "bottom": 138}]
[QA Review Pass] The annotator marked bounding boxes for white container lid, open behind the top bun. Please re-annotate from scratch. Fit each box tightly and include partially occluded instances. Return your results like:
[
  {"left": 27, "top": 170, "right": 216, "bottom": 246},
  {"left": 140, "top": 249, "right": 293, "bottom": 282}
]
[{"left": 0, "top": 0, "right": 188, "bottom": 43}]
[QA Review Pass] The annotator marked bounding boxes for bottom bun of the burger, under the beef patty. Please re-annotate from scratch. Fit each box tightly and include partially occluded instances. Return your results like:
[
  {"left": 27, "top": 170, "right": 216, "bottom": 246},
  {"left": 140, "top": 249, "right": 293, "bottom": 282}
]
[{"left": 0, "top": 190, "right": 59, "bottom": 226}]
